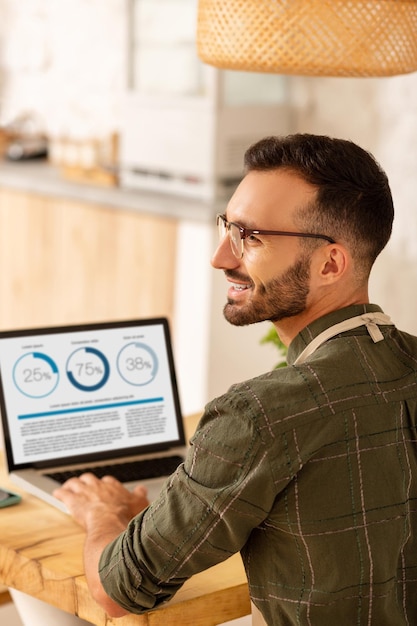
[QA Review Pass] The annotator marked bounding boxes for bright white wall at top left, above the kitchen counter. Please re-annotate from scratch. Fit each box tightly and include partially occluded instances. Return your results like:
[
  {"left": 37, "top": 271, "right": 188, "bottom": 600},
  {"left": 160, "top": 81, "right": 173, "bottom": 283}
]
[{"left": 0, "top": 0, "right": 127, "bottom": 138}]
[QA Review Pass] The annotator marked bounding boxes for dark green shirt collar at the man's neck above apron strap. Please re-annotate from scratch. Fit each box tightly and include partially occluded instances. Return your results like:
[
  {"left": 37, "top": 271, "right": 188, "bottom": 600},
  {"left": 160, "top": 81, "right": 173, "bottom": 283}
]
[{"left": 287, "top": 304, "right": 382, "bottom": 365}]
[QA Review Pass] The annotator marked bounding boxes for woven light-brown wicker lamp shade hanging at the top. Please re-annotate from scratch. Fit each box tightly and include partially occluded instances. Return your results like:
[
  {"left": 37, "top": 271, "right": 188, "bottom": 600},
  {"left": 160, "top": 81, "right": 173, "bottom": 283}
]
[{"left": 197, "top": 0, "right": 417, "bottom": 76}]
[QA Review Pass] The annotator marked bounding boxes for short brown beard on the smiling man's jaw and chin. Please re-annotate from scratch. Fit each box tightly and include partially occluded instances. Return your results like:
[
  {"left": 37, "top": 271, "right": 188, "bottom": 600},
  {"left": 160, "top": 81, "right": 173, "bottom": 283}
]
[{"left": 223, "top": 255, "right": 310, "bottom": 326}]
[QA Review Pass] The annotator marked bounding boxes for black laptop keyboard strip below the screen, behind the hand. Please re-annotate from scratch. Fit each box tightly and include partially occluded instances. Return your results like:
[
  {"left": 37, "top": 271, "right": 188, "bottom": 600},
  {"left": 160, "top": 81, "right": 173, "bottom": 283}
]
[{"left": 46, "top": 455, "right": 183, "bottom": 484}]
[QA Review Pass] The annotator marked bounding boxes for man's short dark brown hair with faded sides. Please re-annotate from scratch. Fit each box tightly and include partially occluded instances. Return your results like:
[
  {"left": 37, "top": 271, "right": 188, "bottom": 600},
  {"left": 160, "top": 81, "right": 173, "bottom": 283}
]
[{"left": 244, "top": 133, "right": 394, "bottom": 275}]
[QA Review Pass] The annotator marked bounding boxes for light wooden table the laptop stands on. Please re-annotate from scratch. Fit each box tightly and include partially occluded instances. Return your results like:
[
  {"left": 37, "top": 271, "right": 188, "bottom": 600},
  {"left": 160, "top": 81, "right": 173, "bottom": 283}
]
[{"left": 0, "top": 418, "right": 250, "bottom": 626}]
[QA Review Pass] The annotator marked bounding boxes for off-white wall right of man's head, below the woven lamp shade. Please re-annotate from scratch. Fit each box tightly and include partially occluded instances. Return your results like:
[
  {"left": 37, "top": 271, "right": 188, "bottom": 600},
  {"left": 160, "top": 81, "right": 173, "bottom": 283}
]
[{"left": 291, "top": 73, "right": 417, "bottom": 334}]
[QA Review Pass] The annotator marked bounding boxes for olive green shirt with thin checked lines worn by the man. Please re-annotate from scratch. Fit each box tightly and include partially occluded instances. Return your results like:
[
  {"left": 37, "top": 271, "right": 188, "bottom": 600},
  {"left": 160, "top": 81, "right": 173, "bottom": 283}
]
[{"left": 100, "top": 305, "right": 417, "bottom": 626}]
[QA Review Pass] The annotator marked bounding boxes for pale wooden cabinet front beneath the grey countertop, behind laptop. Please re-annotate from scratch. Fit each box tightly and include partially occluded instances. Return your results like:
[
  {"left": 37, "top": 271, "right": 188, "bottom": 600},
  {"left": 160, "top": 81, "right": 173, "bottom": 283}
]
[{"left": 0, "top": 189, "right": 177, "bottom": 329}]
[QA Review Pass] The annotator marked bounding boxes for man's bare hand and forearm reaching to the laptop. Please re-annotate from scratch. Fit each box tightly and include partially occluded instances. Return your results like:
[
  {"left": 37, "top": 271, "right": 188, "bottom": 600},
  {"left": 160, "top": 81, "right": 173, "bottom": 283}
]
[{"left": 54, "top": 474, "right": 149, "bottom": 617}]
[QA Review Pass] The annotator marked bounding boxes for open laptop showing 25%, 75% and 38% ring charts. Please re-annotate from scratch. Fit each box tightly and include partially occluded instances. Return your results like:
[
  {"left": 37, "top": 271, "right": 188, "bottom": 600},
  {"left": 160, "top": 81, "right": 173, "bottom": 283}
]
[{"left": 0, "top": 318, "right": 186, "bottom": 512}]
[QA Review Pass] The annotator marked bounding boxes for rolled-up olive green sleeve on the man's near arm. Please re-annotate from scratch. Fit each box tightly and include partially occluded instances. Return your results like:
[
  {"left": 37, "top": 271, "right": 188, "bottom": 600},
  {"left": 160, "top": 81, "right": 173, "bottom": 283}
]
[{"left": 100, "top": 393, "right": 275, "bottom": 613}]
